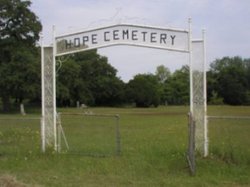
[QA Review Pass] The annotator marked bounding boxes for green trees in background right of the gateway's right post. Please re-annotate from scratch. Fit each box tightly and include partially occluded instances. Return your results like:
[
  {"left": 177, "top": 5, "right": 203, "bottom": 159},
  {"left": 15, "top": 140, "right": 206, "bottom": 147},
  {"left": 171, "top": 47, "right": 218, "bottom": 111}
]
[{"left": 208, "top": 57, "right": 250, "bottom": 105}]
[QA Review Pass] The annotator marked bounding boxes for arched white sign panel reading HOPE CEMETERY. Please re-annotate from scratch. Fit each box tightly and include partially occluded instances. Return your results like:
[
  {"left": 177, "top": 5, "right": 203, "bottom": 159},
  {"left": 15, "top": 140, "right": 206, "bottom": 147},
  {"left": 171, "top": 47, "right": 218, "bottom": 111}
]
[{"left": 55, "top": 24, "right": 189, "bottom": 56}]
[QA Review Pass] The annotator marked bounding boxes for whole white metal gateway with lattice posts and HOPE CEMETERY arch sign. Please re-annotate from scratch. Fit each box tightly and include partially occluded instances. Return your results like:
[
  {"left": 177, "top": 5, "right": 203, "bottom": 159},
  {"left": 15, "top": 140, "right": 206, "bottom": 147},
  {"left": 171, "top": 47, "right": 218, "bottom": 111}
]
[{"left": 41, "top": 19, "right": 208, "bottom": 156}]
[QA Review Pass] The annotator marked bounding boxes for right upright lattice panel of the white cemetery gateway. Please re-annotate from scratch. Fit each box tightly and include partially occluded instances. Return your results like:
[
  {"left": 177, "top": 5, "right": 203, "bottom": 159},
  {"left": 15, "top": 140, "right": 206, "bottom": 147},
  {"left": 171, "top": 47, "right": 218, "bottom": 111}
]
[{"left": 191, "top": 40, "right": 207, "bottom": 156}]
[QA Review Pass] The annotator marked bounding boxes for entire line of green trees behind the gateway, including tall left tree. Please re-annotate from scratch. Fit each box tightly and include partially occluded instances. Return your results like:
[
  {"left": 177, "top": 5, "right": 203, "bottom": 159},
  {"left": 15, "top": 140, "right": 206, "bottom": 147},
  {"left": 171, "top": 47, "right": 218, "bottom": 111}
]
[{"left": 0, "top": 0, "right": 250, "bottom": 111}]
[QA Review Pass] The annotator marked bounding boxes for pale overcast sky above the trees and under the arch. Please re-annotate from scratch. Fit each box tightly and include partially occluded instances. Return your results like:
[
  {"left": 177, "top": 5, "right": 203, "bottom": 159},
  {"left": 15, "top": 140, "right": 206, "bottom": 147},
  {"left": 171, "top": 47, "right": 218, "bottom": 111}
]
[{"left": 31, "top": 0, "right": 250, "bottom": 81}]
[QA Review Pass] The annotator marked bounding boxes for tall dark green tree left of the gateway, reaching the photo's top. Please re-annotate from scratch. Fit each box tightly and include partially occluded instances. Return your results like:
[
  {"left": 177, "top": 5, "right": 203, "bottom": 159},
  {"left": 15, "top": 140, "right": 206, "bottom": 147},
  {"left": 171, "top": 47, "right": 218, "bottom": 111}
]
[{"left": 0, "top": 0, "right": 42, "bottom": 111}]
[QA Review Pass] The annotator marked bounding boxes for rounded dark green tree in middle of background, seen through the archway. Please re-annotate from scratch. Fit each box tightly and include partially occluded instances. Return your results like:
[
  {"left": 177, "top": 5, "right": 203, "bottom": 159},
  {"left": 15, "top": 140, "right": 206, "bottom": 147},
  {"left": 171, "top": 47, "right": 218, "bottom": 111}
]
[{"left": 127, "top": 74, "right": 160, "bottom": 107}]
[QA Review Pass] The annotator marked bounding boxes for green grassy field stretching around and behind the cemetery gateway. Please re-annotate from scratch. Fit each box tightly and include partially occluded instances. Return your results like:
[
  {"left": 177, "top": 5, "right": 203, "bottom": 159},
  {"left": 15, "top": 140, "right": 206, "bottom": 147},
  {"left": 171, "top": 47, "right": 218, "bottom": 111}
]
[{"left": 0, "top": 106, "right": 250, "bottom": 187}]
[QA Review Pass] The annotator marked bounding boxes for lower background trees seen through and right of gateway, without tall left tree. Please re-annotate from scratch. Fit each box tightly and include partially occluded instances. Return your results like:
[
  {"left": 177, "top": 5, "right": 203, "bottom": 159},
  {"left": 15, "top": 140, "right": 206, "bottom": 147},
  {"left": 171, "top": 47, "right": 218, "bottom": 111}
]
[{"left": 57, "top": 53, "right": 250, "bottom": 107}]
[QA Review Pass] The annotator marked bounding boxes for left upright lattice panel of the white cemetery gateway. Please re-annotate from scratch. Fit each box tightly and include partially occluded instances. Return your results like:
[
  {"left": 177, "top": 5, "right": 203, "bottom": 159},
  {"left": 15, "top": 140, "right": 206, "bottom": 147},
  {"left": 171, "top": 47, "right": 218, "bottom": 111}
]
[{"left": 42, "top": 47, "right": 56, "bottom": 150}]
